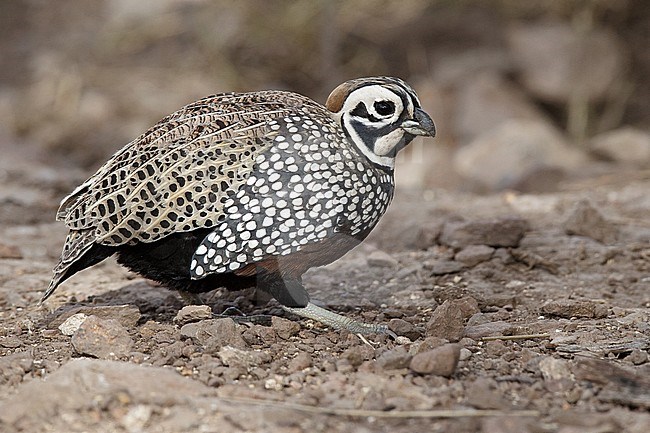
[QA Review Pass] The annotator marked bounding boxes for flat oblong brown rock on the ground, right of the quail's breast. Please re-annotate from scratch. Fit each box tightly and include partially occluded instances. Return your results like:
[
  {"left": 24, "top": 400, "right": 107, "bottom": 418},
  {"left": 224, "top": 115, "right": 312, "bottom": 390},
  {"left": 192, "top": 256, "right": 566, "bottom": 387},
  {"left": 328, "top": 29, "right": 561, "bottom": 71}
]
[{"left": 440, "top": 216, "right": 529, "bottom": 248}]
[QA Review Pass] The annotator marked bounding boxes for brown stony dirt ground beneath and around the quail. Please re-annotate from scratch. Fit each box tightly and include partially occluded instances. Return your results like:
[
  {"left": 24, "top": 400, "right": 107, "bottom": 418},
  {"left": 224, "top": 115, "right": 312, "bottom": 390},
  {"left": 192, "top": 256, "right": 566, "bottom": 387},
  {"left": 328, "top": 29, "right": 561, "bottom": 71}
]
[{"left": 0, "top": 144, "right": 650, "bottom": 433}]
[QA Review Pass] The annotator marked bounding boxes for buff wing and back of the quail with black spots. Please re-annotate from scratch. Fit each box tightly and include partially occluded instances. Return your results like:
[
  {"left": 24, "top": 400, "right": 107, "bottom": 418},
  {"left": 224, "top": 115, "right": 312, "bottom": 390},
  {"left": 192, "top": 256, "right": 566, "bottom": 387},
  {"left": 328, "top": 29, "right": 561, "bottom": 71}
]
[{"left": 57, "top": 91, "right": 325, "bottom": 246}]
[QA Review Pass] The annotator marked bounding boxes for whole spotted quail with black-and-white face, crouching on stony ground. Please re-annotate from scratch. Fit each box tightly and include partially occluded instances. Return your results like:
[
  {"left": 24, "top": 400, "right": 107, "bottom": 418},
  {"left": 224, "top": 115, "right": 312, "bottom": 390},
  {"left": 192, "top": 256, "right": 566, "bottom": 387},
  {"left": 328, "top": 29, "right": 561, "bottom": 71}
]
[{"left": 41, "top": 76, "right": 436, "bottom": 334}]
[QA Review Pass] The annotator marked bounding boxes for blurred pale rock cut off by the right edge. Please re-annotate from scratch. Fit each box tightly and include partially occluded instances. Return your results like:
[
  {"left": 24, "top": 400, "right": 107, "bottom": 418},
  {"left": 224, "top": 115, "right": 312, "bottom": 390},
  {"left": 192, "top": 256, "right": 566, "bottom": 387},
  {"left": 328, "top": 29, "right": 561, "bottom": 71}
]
[{"left": 589, "top": 127, "right": 650, "bottom": 168}]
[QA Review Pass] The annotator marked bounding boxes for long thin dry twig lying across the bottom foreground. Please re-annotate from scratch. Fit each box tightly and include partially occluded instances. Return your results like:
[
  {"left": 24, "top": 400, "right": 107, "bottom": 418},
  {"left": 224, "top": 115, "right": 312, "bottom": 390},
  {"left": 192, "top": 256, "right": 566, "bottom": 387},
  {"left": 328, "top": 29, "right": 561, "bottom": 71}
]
[{"left": 218, "top": 397, "right": 539, "bottom": 418}]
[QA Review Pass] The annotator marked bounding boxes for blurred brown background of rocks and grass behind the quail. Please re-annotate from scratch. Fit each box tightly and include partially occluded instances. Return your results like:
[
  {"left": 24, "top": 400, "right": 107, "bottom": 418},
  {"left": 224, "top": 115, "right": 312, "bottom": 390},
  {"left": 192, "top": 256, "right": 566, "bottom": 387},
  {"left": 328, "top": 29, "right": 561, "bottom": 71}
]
[{"left": 0, "top": 0, "right": 650, "bottom": 192}]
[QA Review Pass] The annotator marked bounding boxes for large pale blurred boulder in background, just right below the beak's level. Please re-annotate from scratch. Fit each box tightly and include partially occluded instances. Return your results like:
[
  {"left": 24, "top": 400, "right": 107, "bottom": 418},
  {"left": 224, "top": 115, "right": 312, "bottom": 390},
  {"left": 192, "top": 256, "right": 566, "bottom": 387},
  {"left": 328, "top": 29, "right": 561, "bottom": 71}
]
[{"left": 453, "top": 119, "right": 587, "bottom": 190}]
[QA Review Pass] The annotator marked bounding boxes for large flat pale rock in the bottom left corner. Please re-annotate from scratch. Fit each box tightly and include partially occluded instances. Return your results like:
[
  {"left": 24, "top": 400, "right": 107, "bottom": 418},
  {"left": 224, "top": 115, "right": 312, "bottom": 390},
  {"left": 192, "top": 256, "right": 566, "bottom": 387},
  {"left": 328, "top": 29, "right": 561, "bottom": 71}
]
[{"left": 0, "top": 358, "right": 215, "bottom": 431}]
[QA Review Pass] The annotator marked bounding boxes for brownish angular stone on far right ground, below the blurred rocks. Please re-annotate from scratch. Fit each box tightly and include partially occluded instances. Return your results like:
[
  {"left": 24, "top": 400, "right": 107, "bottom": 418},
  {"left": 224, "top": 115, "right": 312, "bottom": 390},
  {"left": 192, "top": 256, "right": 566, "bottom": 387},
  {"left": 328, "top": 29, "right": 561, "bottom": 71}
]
[{"left": 564, "top": 200, "right": 618, "bottom": 244}]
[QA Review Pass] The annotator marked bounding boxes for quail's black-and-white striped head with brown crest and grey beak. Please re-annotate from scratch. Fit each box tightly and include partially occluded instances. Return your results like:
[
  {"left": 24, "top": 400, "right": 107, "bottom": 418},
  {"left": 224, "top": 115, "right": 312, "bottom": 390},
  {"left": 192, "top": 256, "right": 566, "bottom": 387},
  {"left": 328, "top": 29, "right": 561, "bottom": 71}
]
[{"left": 325, "top": 77, "right": 436, "bottom": 169}]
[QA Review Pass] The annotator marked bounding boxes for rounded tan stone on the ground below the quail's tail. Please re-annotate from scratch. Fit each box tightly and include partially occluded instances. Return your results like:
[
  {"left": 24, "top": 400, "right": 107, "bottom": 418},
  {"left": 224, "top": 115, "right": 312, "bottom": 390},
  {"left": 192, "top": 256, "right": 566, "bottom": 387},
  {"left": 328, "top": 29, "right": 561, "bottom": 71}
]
[{"left": 72, "top": 316, "right": 133, "bottom": 359}]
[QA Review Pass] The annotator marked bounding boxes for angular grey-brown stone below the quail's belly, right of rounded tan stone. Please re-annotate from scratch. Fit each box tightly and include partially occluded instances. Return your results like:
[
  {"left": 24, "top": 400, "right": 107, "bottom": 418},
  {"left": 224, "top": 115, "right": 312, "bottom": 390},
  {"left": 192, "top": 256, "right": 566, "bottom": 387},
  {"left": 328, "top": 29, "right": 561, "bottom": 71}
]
[{"left": 181, "top": 318, "right": 247, "bottom": 353}]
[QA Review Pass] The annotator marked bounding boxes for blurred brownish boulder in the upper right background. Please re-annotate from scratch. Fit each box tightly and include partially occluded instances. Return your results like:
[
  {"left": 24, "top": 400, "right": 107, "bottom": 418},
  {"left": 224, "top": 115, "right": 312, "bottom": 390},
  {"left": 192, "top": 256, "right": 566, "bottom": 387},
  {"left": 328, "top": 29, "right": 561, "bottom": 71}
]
[{"left": 508, "top": 22, "right": 625, "bottom": 104}]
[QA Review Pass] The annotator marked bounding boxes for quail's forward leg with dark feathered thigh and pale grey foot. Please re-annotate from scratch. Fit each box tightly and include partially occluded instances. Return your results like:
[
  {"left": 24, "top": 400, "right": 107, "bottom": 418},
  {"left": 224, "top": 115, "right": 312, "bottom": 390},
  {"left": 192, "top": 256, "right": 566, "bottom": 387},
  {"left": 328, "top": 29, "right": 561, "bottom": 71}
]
[{"left": 266, "top": 278, "right": 395, "bottom": 337}]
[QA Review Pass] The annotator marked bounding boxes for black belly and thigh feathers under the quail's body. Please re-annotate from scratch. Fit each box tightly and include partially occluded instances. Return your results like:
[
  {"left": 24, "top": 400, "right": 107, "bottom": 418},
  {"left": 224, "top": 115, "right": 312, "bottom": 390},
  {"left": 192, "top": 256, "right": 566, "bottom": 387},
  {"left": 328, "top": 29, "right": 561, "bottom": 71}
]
[{"left": 64, "top": 229, "right": 309, "bottom": 307}]
